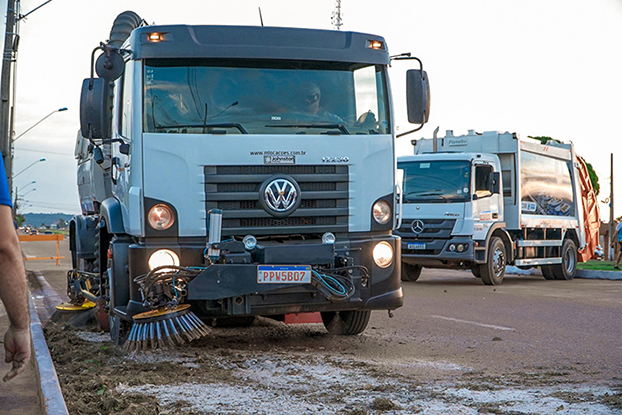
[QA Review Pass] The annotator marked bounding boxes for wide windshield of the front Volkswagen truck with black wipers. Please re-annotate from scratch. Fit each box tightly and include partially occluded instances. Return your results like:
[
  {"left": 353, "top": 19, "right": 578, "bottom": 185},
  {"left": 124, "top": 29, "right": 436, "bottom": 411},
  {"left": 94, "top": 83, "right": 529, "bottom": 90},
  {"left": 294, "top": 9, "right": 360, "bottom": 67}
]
[{"left": 143, "top": 59, "right": 391, "bottom": 135}]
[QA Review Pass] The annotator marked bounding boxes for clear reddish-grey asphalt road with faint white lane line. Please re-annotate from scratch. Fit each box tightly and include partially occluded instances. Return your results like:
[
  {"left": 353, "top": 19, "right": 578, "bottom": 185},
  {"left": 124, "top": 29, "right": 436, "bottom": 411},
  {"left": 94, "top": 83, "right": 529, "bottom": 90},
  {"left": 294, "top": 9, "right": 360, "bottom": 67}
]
[{"left": 22, "top": 241, "right": 622, "bottom": 384}]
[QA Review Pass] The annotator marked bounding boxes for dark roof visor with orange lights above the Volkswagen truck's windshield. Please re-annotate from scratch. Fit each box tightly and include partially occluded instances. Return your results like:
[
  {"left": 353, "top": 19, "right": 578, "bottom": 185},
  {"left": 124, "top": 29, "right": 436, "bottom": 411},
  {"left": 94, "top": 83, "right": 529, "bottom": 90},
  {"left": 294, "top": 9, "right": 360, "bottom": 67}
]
[{"left": 129, "top": 25, "right": 390, "bottom": 65}]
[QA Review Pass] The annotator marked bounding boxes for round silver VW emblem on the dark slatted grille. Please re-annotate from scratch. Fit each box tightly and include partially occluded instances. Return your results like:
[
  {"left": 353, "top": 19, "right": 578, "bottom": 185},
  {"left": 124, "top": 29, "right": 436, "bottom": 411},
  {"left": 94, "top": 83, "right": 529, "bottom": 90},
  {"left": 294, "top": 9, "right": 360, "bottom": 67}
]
[{"left": 259, "top": 176, "right": 300, "bottom": 217}]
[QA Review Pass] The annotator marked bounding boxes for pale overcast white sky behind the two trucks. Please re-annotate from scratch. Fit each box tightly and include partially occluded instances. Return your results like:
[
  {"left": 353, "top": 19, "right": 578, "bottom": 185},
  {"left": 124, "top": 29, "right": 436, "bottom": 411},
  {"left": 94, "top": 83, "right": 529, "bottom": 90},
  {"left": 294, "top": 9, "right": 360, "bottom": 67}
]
[{"left": 0, "top": 0, "right": 622, "bottom": 221}]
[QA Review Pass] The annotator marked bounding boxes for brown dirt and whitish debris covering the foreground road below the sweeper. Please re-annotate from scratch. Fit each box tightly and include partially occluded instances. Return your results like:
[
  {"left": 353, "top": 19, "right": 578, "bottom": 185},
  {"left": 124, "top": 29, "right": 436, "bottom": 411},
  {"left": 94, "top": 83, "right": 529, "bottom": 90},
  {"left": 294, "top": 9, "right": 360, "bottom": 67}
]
[{"left": 46, "top": 316, "right": 622, "bottom": 415}]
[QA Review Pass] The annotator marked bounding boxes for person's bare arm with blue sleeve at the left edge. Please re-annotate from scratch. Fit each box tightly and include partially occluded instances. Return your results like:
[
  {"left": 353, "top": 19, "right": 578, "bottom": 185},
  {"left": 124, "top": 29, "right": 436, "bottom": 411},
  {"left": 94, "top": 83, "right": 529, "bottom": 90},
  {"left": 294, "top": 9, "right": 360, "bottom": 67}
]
[{"left": 0, "top": 157, "right": 30, "bottom": 382}]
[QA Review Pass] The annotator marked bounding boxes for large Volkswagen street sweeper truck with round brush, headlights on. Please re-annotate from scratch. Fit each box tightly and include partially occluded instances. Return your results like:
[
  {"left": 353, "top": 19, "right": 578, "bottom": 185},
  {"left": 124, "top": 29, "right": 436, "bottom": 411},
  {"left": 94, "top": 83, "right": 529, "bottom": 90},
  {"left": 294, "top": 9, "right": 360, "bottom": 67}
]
[{"left": 67, "top": 12, "right": 429, "bottom": 349}]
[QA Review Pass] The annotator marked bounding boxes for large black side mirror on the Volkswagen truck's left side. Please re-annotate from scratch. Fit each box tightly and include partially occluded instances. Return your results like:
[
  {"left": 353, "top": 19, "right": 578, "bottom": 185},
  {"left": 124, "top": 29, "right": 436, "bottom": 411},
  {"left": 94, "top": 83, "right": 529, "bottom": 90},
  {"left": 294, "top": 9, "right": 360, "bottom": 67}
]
[{"left": 80, "top": 78, "right": 112, "bottom": 138}]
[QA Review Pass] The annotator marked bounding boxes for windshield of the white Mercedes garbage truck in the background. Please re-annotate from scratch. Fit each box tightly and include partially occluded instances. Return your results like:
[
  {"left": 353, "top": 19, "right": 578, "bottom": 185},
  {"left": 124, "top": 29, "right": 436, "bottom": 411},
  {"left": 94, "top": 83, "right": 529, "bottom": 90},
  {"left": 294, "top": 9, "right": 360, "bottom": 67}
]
[{"left": 397, "top": 160, "right": 471, "bottom": 203}]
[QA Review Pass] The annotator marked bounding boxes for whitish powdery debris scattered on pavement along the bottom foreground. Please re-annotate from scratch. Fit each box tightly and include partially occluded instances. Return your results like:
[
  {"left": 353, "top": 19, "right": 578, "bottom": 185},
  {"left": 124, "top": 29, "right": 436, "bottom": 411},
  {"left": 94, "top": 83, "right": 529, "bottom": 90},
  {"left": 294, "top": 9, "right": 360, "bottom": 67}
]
[{"left": 116, "top": 355, "right": 619, "bottom": 415}]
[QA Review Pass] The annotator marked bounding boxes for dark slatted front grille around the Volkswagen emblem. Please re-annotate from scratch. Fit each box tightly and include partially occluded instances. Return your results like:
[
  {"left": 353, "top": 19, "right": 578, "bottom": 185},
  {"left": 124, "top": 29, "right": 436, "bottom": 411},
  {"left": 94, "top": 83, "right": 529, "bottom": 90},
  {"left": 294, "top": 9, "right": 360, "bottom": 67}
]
[{"left": 204, "top": 165, "right": 349, "bottom": 236}]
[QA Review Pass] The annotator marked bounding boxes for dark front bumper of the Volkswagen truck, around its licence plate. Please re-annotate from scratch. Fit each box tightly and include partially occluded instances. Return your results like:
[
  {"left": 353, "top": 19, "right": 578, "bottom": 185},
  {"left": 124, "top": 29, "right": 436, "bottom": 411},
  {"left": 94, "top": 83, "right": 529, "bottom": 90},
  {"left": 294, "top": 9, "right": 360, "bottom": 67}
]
[{"left": 127, "top": 234, "right": 403, "bottom": 316}]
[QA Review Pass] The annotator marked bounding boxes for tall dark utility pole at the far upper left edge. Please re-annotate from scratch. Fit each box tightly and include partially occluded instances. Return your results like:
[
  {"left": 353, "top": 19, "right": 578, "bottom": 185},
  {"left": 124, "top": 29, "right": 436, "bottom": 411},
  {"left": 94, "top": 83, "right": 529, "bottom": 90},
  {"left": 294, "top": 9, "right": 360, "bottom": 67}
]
[{"left": 0, "top": 0, "right": 19, "bottom": 198}]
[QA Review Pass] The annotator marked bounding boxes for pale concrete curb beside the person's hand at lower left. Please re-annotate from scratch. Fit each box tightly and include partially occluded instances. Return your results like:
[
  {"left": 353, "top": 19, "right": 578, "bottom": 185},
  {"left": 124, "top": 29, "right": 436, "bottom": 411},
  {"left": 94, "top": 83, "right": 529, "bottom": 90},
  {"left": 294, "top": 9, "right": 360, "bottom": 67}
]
[{"left": 29, "top": 272, "right": 69, "bottom": 415}]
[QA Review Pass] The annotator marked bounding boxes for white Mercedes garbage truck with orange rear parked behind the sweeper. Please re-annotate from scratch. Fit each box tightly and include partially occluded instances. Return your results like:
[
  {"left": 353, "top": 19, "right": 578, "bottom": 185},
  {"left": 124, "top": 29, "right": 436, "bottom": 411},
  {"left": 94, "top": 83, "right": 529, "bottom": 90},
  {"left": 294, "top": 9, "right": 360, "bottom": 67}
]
[{"left": 396, "top": 130, "right": 599, "bottom": 285}]
